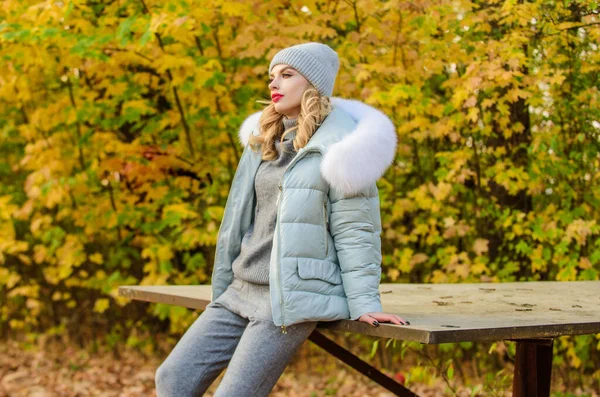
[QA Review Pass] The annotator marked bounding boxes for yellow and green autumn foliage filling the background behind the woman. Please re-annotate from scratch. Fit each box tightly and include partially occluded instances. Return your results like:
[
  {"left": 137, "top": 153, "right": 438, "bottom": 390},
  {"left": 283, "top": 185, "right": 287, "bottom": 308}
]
[{"left": 0, "top": 0, "right": 600, "bottom": 390}]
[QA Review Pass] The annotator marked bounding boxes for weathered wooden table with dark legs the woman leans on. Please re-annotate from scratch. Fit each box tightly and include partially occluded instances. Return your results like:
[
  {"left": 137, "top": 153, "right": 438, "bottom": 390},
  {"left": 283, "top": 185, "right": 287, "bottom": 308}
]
[{"left": 119, "top": 281, "right": 600, "bottom": 397}]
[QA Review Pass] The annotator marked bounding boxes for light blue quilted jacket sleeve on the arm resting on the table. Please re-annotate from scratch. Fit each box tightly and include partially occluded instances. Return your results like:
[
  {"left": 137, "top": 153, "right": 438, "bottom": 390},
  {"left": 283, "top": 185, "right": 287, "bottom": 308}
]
[{"left": 329, "top": 182, "right": 382, "bottom": 320}]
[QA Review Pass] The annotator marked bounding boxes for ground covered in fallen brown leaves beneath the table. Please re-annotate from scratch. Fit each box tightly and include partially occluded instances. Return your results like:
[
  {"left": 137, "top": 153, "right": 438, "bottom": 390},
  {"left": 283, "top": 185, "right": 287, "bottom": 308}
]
[{"left": 0, "top": 341, "right": 598, "bottom": 397}]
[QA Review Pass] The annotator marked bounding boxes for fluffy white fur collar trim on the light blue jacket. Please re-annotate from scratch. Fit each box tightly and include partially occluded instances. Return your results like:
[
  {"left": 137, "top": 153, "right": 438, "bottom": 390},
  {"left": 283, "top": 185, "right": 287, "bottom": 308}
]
[{"left": 238, "top": 97, "right": 397, "bottom": 194}]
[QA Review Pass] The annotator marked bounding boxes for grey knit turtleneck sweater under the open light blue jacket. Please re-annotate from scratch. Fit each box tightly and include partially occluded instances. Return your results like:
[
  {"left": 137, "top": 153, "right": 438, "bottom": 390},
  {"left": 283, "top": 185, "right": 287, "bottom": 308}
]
[{"left": 232, "top": 117, "right": 297, "bottom": 284}]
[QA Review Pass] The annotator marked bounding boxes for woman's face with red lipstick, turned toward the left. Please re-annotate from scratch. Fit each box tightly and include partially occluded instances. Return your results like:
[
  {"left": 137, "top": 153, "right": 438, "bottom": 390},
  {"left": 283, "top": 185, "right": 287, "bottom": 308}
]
[{"left": 269, "top": 64, "right": 311, "bottom": 119}]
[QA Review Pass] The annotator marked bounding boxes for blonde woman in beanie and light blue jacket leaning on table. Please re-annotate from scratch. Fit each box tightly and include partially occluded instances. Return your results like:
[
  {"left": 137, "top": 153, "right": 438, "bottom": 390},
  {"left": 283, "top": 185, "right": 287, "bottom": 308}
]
[{"left": 156, "top": 43, "right": 408, "bottom": 397}]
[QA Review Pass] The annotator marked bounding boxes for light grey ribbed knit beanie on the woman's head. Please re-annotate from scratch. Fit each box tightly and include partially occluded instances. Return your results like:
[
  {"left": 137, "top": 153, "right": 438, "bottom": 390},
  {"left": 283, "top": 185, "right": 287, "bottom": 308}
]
[{"left": 269, "top": 42, "right": 340, "bottom": 96}]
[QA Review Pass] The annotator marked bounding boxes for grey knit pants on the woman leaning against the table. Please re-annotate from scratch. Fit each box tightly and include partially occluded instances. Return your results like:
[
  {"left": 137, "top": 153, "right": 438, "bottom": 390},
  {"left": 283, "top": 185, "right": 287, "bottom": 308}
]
[{"left": 155, "top": 277, "right": 317, "bottom": 397}]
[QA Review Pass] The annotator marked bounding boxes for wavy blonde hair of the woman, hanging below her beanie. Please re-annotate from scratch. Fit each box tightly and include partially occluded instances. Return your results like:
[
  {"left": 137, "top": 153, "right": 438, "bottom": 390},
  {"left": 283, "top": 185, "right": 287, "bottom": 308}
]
[{"left": 248, "top": 87, "right": 331, "bottom": 160}]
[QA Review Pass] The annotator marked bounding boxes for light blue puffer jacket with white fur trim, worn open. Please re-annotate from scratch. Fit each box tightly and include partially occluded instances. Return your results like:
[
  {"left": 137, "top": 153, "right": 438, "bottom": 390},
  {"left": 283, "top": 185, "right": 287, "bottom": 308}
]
[{"left": 212, "top": 97, "right": 397, "bottom": 332}]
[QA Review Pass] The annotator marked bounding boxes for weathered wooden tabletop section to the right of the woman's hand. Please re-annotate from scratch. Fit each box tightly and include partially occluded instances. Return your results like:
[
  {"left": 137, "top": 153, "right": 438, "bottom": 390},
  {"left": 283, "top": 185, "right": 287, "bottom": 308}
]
[{"left": 372, "top": 281, "right": 600, "bottom": 343}]
